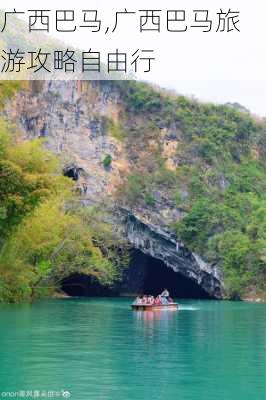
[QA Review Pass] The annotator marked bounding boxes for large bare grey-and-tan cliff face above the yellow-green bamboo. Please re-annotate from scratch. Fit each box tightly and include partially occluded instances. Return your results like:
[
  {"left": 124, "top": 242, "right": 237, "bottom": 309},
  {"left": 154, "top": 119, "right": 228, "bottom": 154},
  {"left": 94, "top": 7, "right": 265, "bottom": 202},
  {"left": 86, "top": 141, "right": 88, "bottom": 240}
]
[{"left": 6, "top": 81, "right": 127, "bottom": 201}]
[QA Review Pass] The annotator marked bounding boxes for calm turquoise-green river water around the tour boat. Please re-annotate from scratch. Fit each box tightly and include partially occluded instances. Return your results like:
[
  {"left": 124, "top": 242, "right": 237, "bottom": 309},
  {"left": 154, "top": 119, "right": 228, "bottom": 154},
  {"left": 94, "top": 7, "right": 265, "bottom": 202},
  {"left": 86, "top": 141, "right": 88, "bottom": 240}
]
[{"left": 0, "top": 298, "right": 266, "bottom": 400}]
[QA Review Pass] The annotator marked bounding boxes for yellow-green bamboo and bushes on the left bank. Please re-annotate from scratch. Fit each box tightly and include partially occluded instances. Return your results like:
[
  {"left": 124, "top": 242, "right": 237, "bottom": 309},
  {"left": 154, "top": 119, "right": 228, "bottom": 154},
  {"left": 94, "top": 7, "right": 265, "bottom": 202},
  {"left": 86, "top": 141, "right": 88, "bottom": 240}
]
[{"left": 0, "top": 120, "right": 127, "bottom": 302}]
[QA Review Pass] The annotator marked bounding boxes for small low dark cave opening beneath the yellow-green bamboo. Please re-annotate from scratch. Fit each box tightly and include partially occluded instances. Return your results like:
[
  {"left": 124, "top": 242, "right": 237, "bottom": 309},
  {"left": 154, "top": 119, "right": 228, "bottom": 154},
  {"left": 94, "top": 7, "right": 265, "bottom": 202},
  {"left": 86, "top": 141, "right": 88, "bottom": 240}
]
[{"left": 61, "top": 274, "right": 114, "bottom": 297}]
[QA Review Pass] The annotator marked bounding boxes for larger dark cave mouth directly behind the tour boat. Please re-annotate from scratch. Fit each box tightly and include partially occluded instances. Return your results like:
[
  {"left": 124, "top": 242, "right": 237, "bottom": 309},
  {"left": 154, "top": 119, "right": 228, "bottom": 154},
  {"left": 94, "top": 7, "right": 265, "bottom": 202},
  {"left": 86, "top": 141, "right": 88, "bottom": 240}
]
[{"left": 127, "top": 250, "right": 211, "bottom": 299}]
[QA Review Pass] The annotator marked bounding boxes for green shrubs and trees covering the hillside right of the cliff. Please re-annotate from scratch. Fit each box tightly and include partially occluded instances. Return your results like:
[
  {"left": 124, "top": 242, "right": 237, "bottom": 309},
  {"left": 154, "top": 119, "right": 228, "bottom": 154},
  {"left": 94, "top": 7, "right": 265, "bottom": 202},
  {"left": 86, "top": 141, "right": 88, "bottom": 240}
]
[{"left": 115, "top": 82, "right": 266, "bottom": 298}]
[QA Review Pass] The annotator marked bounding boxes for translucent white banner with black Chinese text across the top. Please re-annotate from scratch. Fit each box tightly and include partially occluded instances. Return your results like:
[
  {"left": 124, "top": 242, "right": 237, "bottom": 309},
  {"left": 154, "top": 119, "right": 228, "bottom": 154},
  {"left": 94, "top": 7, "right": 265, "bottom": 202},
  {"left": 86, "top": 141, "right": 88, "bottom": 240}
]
[{"left": 0, "top": 0, "right": 266, "bottom": 81}]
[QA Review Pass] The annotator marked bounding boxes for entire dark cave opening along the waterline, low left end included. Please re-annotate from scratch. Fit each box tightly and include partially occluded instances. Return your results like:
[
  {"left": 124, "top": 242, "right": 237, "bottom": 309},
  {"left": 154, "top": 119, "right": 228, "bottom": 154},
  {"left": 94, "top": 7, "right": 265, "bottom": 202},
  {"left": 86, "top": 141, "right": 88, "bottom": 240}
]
[{"left": 61, "top": 250, "right": 212, "bottom": 299}]
